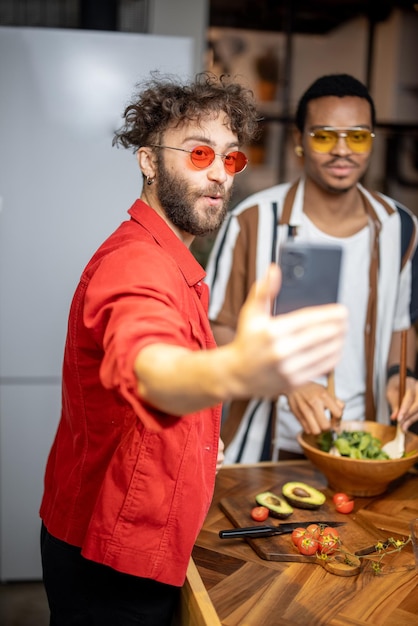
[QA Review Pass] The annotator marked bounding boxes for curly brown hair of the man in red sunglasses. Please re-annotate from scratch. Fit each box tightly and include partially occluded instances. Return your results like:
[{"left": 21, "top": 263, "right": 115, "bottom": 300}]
[{"left": 112, "top": 72, "right": 258, "bottom": 152}]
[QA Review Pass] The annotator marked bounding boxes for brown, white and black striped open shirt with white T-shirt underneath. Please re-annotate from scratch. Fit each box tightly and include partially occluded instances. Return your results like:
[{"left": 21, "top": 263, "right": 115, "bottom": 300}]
[{"left": 206, "top": 179, "right": 418, "bottom": 463}]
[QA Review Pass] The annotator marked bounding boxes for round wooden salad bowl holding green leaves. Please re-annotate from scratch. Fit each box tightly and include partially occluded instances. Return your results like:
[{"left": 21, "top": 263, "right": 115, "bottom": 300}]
[{"left": 297, "top": 421, "right": 418, "bottom": 497}]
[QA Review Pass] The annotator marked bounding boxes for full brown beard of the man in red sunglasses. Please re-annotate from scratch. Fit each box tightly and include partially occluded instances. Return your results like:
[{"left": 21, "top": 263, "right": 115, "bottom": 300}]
[{"left": 157, "top": 159, "right": 232, "bottom": 237}]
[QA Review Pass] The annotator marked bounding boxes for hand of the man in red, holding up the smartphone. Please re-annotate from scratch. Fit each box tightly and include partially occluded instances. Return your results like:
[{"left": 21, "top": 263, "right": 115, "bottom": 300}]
[{"left": 229, "top": 264, "right": 347, "bottom": 398}]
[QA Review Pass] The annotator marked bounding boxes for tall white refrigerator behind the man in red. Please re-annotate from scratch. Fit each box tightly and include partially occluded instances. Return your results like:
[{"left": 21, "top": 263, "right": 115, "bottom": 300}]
[{"left": 0, "top": 27, "right": 193, "bottom": 581}]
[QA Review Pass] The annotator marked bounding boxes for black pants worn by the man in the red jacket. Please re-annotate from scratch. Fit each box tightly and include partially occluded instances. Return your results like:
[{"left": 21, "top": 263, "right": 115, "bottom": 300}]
[{"left": 41, "top": 525, "right": 180, "bottom": 626}]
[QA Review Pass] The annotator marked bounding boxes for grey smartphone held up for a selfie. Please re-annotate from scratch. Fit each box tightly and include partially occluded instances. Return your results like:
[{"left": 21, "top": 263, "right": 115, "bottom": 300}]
[{"left": 274, "top": 241, "right": 343, "bottom": 315}]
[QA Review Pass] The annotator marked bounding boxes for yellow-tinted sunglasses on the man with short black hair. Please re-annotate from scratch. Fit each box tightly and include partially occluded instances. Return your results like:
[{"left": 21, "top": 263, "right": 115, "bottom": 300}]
[{"left": 309, "top": 126, "right": 375, "bottom": 154}]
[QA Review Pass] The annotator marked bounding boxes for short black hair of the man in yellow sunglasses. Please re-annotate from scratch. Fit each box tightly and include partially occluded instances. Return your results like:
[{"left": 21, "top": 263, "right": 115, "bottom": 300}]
[{"left": 295, "top": 74, "right": 376, "bottom": 132}]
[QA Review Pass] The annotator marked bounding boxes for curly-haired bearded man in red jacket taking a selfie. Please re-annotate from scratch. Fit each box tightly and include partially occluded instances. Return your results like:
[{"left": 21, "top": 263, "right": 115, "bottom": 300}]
[{"left": 40, "top": 74, "right": 346, "bottom": 626}]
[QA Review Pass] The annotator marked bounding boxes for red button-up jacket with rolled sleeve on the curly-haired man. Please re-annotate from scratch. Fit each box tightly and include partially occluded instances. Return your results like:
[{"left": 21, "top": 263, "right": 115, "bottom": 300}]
[{"left": 40, "top": 200, "right": 220, "bottom": 586}]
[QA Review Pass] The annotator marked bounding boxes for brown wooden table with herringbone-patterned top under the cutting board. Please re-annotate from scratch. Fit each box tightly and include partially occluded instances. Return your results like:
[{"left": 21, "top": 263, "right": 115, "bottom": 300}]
[{"left": 177, "top": 461, "right": 418, "bottom": 626}]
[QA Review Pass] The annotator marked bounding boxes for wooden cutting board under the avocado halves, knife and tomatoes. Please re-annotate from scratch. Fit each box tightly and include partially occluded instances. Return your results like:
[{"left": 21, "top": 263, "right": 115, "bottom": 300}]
[{"left": 219, "top": 485, "right": 382, "bottom": 563}]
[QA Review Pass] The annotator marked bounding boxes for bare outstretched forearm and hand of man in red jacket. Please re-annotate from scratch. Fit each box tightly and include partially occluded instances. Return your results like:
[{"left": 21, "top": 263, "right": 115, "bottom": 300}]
[{"left": 135, "top": 265, "right": 347, "bottom": 415}]
